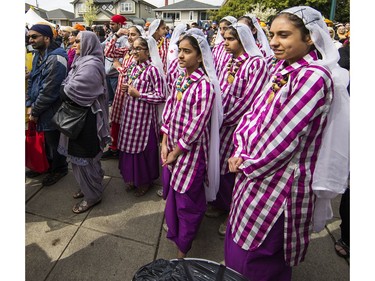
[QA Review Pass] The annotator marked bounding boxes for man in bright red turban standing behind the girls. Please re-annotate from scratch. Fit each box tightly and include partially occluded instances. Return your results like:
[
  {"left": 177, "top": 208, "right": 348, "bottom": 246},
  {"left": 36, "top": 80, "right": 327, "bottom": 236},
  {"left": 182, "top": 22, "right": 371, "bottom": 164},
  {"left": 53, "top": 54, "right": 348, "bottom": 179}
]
[{"left": 101, "top": 15, "right": 128, "bottom": 105}]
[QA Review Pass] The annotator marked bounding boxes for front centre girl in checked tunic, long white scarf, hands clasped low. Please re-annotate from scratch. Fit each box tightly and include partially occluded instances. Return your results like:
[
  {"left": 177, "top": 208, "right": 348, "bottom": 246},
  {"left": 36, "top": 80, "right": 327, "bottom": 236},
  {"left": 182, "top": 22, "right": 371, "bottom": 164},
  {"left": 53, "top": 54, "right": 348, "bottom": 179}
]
[{"left": 161, "top": 31, "right": 222, "bottom": 258}]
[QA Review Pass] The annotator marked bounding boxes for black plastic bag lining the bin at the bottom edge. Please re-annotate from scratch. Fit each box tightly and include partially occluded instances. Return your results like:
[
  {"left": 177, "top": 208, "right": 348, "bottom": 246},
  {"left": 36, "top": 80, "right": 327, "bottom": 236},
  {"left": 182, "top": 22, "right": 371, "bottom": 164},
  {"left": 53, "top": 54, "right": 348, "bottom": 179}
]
[{"left": 132, "top": 258, "right": 249, "bottom": 281}]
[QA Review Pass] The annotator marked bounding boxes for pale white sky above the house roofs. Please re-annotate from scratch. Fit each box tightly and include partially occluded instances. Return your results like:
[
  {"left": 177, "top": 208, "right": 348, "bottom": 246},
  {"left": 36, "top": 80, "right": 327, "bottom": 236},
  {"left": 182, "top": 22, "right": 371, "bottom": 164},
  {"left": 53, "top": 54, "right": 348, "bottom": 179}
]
[{"left": 26, "top": 0, "right": 222, "bottom": 12}]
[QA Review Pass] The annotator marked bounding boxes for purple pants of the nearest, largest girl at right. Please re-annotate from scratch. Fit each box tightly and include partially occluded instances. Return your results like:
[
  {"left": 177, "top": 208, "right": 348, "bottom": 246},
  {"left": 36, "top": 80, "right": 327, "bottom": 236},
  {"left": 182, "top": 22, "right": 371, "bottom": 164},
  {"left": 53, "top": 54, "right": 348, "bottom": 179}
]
[{"left": 224, "top": 215, "right": 292, "bottom": 281}]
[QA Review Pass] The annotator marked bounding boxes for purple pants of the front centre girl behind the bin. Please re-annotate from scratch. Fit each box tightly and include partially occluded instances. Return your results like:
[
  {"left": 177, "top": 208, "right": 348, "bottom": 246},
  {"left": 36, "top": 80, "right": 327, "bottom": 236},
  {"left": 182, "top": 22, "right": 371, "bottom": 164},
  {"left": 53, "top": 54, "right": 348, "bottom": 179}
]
[{"left": 163, "top": 151, "right": 207, "bottom": 254}]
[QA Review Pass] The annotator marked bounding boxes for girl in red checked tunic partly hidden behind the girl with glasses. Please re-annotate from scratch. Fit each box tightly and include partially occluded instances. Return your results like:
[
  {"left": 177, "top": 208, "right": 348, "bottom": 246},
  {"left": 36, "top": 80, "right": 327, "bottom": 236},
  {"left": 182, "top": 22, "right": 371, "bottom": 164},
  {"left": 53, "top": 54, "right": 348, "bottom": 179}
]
[{"left": 103, "top": 25, "right": 145, "bottom": 159}]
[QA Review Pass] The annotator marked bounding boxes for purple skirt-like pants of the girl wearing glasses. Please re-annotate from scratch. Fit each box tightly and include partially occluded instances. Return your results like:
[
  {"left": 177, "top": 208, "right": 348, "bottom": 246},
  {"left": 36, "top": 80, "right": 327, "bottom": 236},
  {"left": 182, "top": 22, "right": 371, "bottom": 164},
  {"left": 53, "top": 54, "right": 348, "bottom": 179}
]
[{"left": 119, "top": 126, "right": 159, "bottom": 187}]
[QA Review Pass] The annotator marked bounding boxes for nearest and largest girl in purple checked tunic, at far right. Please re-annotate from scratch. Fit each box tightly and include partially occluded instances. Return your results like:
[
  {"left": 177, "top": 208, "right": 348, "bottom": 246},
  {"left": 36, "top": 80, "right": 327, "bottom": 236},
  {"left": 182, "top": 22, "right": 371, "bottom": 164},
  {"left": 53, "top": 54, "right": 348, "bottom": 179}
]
[{"left": 225, "top": 6, "right": 347, "bottom": 281}]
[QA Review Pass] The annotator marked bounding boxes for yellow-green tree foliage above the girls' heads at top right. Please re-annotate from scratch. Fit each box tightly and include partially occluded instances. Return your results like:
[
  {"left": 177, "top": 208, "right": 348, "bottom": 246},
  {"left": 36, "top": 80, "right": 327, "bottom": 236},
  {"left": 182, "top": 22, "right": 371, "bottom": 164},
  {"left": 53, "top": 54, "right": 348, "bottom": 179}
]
[{"left": 210, "top": 0, "right": 350, "bottom": 22}]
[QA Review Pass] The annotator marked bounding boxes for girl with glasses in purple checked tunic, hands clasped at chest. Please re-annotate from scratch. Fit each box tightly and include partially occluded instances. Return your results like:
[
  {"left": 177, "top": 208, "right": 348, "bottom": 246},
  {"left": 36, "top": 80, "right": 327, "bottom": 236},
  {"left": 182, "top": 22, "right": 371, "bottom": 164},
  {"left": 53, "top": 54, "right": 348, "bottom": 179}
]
[{"left": 118, "top": 37, "right": 165, "bottom": 196}]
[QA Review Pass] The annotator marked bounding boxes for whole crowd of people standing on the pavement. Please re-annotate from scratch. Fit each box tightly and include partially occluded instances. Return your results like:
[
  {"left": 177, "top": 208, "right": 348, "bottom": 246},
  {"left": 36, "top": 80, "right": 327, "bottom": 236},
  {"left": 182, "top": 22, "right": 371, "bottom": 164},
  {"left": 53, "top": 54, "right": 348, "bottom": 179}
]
[{"left": 26, "top": 6, "right": 350, "bottom": 280}]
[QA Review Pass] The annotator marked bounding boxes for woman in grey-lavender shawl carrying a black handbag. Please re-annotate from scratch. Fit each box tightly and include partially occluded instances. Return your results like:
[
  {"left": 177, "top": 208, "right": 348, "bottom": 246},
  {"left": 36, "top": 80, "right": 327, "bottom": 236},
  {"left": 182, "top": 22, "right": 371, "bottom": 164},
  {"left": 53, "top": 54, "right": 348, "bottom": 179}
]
[{"left": 59, "top": 31, "right": 109, "bottom": 214}]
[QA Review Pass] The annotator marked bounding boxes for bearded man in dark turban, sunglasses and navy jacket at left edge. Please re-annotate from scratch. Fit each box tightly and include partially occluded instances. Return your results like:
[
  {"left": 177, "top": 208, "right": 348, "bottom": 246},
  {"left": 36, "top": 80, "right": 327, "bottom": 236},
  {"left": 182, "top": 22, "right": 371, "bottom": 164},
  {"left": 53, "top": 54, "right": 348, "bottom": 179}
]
[{"left": 26, "top": 23, "right": 68, "bottom": 186}]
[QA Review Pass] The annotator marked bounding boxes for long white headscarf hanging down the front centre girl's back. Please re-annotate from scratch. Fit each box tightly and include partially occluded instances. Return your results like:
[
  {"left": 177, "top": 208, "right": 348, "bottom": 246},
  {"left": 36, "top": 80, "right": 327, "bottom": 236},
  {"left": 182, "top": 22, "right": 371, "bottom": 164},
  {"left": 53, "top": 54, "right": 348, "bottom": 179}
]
[{"left": 186, "top": 28, "right": 223, "bottom": 202}]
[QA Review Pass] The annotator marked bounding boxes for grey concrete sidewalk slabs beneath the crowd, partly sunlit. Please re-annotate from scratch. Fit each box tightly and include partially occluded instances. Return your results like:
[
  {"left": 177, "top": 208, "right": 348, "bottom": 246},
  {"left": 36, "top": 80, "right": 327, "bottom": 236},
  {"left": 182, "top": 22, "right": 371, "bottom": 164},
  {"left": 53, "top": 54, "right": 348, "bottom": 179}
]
[{"left": 25, "top": 160, "right": 349, "bottom": 281}]
